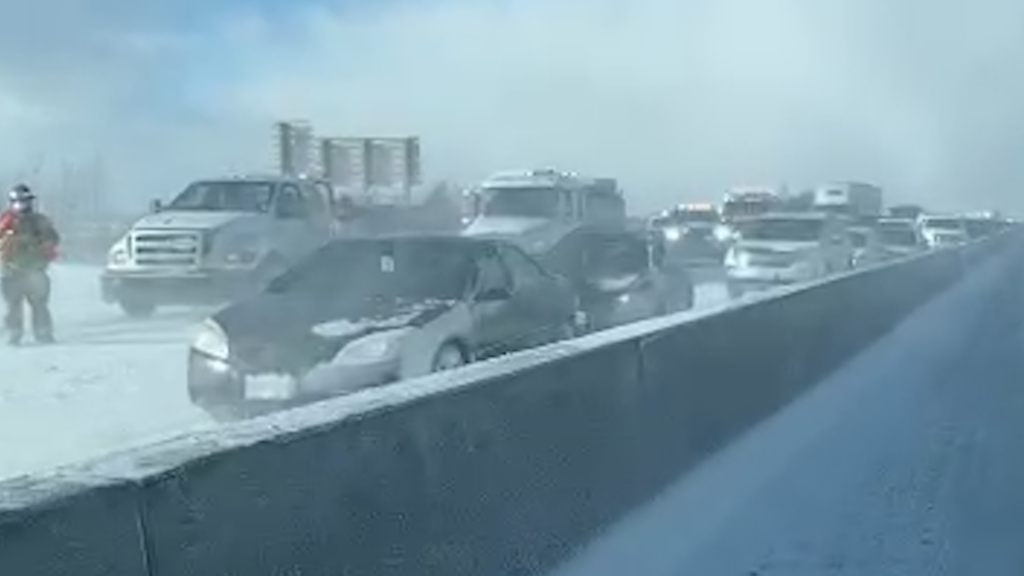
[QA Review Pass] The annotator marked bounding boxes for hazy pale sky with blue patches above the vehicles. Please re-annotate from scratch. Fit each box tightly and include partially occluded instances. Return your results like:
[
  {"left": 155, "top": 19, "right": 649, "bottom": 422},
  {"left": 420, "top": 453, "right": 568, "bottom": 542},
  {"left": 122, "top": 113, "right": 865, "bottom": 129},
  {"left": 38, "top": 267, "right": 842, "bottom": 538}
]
[{"left": 0, "top": 0, "right": 1024, "bottom": 211}]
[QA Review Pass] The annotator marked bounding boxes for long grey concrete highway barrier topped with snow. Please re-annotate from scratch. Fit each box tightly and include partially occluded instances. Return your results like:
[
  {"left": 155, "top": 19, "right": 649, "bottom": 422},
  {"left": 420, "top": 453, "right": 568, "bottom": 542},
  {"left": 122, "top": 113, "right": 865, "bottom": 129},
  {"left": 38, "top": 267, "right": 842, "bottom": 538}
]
[{"left": 0, "top": 229, "right": 1019, "bottom": 576}]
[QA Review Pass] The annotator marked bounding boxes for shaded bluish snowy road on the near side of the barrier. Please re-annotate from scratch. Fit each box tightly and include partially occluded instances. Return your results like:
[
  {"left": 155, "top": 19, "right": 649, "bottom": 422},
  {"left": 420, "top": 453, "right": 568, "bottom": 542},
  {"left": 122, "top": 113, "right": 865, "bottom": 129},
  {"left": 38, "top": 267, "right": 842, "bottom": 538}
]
[{"left": 556, "top": 245, "right": 1024, "bottom": 576}]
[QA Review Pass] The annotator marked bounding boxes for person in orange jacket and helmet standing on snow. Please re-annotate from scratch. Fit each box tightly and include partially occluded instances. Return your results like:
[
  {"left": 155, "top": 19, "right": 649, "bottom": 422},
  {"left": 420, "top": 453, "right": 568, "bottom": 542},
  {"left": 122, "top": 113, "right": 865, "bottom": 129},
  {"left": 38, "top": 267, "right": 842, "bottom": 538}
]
[{"left": 0, "top": 184, "right": 60, "bottom": 345}]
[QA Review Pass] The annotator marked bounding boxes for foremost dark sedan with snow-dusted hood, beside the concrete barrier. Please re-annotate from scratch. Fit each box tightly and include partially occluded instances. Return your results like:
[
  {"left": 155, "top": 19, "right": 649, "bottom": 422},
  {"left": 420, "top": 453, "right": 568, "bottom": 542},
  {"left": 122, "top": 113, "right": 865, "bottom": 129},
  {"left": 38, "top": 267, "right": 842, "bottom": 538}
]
[{"left": 188, "top": 231, "right": 582, "bottom": 418}]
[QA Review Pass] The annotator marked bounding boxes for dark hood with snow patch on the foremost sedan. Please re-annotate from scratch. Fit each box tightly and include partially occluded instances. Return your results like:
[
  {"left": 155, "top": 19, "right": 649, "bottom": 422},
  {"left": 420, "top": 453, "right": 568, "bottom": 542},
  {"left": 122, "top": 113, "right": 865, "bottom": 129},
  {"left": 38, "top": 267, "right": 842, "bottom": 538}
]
[{"left": 213, "top": 294, "right": 456, "bottom": 374}]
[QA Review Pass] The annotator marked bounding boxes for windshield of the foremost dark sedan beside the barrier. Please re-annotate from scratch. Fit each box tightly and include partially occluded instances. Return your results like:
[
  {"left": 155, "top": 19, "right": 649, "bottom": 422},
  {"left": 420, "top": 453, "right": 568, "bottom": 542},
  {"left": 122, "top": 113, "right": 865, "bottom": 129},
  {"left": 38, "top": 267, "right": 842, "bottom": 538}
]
[{"left": 269, "top": 239, "right": 475, "bottom": 305}]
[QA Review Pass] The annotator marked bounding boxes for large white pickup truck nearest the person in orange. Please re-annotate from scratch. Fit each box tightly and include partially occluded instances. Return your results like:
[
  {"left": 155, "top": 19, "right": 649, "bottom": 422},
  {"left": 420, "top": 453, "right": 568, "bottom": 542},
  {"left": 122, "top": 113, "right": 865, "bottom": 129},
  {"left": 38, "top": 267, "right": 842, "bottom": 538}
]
[{"left": 100, "top": 176, "right": 335, "bottom": 317}]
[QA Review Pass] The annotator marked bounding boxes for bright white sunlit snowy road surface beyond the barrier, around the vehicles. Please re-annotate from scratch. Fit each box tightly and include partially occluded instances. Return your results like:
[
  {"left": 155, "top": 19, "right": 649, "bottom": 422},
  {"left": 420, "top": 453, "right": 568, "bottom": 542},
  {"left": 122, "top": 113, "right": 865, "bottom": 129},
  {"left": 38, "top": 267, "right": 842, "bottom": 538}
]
[{"left": 0, "top": 265, "right": 726, "bottom": 479}]
